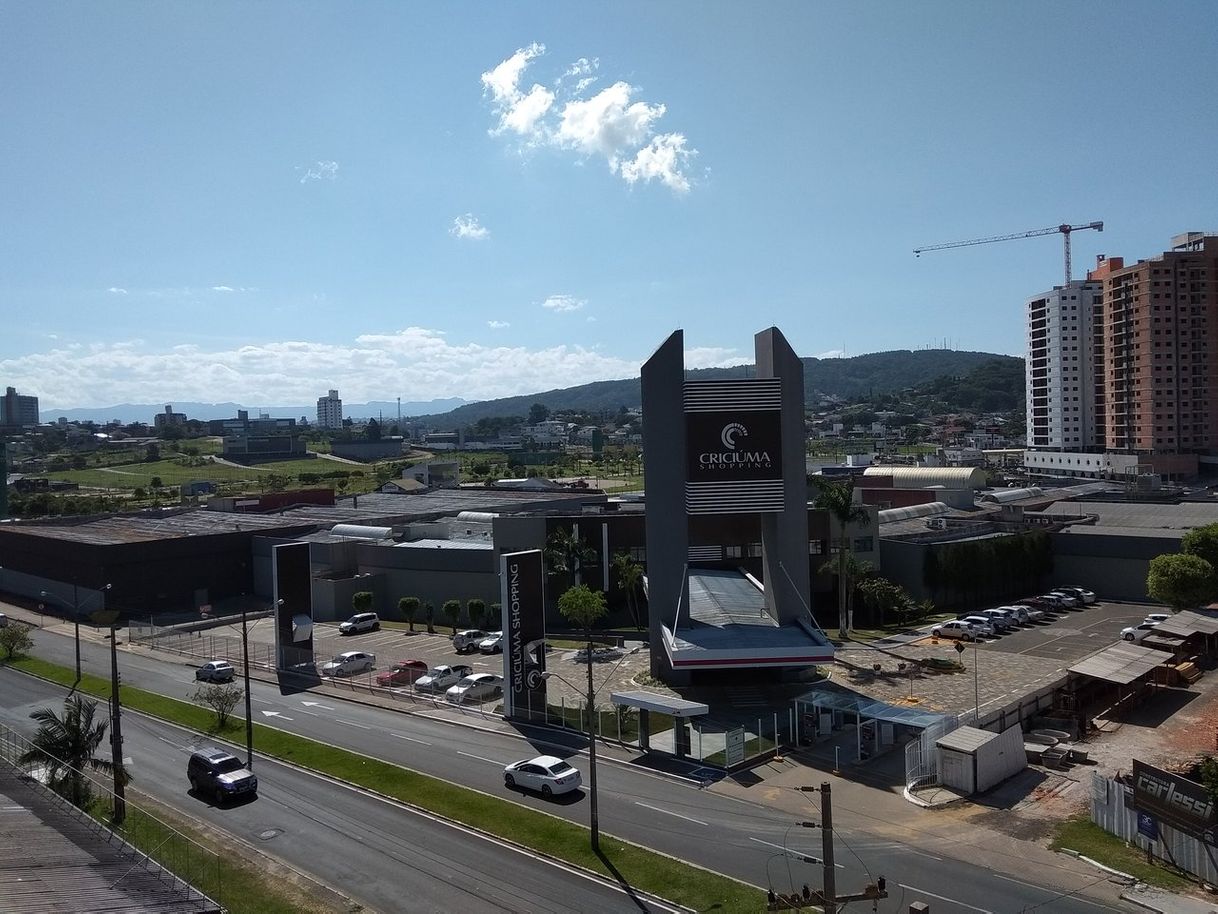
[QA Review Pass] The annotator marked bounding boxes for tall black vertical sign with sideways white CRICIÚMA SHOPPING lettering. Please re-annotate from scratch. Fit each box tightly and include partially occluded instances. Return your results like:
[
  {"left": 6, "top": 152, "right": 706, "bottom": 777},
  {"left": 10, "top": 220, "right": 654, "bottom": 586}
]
[{"left": 499, "top": 550, "right": 546, "bottom": 719}]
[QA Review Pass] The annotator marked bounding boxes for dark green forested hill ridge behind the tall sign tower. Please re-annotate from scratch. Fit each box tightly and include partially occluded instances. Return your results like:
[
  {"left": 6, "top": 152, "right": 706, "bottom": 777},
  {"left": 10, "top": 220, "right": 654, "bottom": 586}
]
[{"left": 414, "top": 350, "right": 1023, "bottom": 429}]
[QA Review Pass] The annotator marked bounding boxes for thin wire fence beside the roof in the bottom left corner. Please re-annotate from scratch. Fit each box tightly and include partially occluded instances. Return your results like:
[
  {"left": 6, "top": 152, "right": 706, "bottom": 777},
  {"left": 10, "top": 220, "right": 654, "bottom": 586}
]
[{"left": 0, "top": 724, "right": 224, "bottom": 912}]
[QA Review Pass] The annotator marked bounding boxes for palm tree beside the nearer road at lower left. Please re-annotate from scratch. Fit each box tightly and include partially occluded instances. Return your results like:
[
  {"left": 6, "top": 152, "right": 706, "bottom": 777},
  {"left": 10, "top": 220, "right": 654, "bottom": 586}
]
[{"left": 19, "top": 695, "right": 130, "bottom": 808}]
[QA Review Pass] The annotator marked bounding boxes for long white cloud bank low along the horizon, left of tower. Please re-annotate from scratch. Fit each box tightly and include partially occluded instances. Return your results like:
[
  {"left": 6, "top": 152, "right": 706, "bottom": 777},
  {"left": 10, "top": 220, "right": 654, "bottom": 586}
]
[{"left": 0, "top": 327, "right": 639, "bottom": 409}]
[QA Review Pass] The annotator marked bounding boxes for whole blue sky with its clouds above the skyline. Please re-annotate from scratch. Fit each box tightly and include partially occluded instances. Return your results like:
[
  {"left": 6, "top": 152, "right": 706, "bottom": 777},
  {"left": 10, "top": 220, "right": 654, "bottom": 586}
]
[{"left": 0, "top": 0, "right": 1218, "bottom": 409}]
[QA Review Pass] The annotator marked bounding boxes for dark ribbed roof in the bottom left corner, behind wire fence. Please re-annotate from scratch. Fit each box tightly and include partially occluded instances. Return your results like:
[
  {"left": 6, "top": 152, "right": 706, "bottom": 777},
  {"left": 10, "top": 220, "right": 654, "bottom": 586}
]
[{"left": 0, "top": 762, "right": 220, "bottom": 914}]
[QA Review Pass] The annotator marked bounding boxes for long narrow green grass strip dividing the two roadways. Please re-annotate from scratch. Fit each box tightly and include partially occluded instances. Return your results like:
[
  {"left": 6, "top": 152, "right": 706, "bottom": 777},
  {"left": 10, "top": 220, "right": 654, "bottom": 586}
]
[{"left": 9, "top": 657, "right": 766, "bottom": 912}]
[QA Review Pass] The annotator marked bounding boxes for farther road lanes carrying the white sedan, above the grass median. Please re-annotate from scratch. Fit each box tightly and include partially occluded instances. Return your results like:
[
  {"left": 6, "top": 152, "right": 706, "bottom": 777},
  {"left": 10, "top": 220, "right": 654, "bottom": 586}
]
[{"left": 21, "top": 631, "right": 1136, "bottom": 914}]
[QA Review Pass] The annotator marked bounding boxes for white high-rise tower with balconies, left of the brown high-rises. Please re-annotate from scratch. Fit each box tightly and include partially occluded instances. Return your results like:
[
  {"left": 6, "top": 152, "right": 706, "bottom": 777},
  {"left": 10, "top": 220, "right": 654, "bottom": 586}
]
[{"left": 1024, "top": 279, "right": 1104, "bottom": 451}]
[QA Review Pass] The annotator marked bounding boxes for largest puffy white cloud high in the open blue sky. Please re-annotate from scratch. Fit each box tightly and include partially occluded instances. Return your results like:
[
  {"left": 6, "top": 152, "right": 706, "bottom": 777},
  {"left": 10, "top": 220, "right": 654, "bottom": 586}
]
[{"left": 482, "top": 43, "right": 698, "bottom": 194}]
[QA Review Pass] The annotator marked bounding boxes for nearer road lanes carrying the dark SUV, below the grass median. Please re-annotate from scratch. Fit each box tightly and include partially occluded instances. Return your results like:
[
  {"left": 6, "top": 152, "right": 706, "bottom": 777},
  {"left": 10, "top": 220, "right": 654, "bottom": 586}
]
[{"left": 0, "top": 669, "right": 667, "bottom": 913}]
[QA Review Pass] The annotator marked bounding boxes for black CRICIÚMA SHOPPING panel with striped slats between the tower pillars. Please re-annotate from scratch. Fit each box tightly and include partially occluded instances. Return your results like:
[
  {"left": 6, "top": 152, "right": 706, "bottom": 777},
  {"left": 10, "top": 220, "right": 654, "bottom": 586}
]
[{"left": 685, "top": 378, "right": 784, "bottom": 514}]
